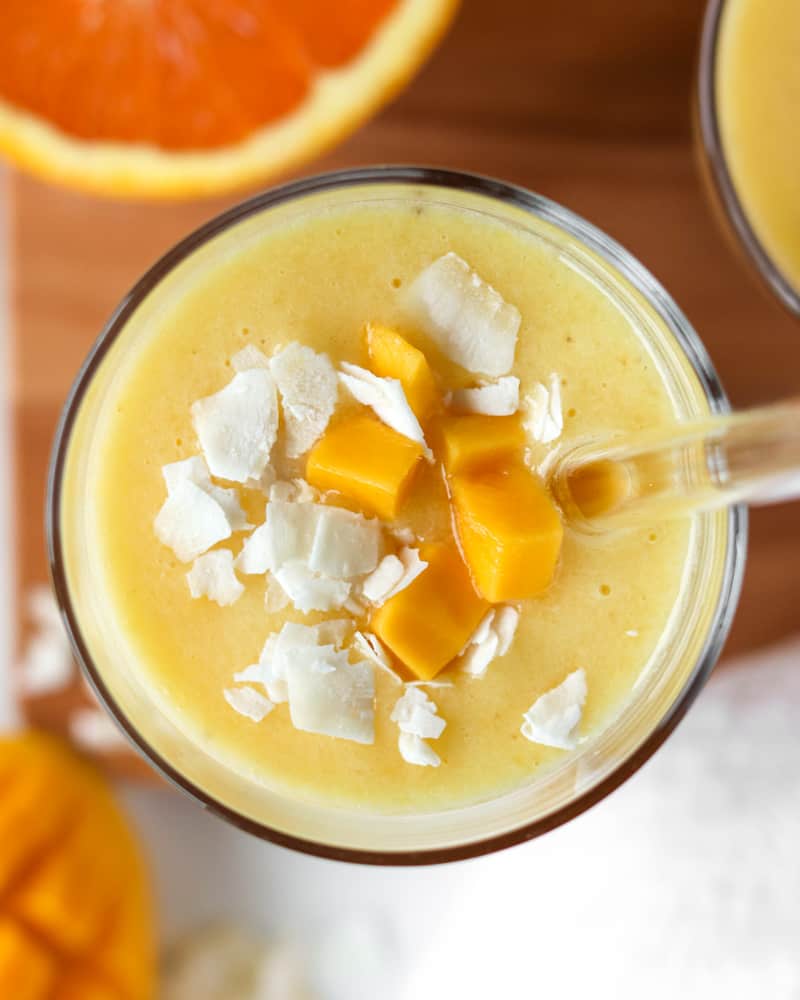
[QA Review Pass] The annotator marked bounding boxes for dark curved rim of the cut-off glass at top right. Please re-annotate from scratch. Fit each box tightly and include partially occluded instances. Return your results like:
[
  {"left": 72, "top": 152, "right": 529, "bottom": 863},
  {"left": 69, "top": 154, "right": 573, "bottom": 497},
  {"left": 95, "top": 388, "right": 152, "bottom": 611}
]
[{"left": 695, "top": 0, "right": 800, "bottom": 318}]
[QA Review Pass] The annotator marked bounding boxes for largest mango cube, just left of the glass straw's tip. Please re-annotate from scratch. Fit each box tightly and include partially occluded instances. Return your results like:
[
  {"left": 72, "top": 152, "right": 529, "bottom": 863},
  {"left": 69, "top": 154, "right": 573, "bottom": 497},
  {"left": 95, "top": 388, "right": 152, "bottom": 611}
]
[{"left": 450, "top": 464, "right": 564, "bottom": 604}]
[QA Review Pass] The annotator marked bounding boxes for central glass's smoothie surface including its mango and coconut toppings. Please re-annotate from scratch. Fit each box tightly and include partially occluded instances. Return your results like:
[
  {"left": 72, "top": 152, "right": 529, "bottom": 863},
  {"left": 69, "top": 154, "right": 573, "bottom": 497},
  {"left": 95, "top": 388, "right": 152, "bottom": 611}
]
[{"left": 76, "top": 199, "right": 693, "bottom": 813}]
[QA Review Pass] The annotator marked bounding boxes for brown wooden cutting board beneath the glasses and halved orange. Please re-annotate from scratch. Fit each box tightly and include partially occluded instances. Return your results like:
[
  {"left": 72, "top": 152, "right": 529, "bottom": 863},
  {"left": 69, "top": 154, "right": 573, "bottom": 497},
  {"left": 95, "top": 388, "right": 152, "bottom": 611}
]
[{"left": 12, "top": 0, "right": 800, "bottom": 780}]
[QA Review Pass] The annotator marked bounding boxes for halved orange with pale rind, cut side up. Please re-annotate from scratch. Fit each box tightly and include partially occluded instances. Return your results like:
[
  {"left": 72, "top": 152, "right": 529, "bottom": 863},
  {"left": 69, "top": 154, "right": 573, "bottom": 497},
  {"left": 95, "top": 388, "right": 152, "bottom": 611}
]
[{"left": 0, "top": 0, "right": 458, "bottom": 197}]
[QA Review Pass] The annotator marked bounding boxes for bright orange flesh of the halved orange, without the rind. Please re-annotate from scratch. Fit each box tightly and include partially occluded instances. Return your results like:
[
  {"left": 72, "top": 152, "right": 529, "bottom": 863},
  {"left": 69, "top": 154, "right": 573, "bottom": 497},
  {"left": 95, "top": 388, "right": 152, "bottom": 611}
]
[{"left": 0, "top": 0, "right": 399, "bottom": 151}]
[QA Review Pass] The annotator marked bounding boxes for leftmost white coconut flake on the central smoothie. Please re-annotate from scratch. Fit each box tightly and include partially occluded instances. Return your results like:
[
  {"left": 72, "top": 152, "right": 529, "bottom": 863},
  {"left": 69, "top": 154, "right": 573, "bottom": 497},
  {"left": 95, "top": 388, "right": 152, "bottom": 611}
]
[{"left": 153, "top": 479, "right": 231, "bottom": 562}]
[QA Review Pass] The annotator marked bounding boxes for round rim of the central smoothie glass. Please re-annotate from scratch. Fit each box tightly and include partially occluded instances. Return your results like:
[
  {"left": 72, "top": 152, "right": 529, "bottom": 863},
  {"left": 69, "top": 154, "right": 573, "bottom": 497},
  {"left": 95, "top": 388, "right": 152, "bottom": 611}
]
[{"left": 45, "top": 165, "right": 747, "bottom": 866}]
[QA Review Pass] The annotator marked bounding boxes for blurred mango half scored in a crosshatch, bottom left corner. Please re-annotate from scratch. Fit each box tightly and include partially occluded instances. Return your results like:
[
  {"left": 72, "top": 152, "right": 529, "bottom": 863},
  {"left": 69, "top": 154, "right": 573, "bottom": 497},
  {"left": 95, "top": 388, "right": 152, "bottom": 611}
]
[{"left": 0, "top": 733, "right": 156, "bottom": 1000}]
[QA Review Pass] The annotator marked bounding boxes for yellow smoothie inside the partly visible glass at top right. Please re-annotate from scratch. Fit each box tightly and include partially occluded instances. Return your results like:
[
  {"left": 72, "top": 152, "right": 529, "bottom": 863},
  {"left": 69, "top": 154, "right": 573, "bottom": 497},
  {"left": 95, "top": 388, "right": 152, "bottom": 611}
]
[{"left": 715, "top": 0, "right": 800, "bottom": 289}]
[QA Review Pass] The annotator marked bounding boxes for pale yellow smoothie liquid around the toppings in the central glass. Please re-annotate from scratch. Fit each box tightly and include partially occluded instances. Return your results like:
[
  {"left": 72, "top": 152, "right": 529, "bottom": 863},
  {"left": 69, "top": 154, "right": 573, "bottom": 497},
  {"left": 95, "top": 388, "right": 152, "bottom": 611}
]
[{"left": 66, "top": 193, "right": 704, "bottom": 813}]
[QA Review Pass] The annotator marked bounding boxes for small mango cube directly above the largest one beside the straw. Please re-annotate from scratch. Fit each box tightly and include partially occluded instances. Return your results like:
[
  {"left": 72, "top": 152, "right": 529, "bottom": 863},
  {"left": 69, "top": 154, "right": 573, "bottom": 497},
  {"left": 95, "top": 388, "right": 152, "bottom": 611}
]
[{"left": 438, "top": 413, "right": 525, "bottom": 476}]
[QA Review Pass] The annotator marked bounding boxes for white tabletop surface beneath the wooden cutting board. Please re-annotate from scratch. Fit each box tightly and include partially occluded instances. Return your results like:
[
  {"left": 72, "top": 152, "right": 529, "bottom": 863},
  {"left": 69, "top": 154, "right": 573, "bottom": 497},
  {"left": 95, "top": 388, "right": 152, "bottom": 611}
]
[{"left": 0, "top": 174, "right": 800, "bottom": 1000}]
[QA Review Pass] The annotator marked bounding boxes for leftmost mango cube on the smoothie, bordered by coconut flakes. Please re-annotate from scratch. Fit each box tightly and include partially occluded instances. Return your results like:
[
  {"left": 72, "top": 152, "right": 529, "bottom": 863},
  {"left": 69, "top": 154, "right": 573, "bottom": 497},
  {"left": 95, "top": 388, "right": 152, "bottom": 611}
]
[{"left": 306, "top": 413, "right": 422, "bottom": 521}]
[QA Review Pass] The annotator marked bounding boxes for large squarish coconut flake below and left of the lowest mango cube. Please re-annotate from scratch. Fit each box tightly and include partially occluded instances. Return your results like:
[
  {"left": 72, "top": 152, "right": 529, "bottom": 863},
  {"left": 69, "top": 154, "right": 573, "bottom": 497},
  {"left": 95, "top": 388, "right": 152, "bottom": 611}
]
[{"left": 287, "top": 646, "right": 375, "bottom": 744}]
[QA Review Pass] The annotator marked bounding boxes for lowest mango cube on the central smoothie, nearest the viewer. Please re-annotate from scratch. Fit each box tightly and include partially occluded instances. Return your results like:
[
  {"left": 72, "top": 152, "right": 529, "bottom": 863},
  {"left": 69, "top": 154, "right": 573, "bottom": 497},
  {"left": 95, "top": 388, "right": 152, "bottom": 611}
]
[{"left": 370, "top": 541, "right": 488, "bottom": 680}]
